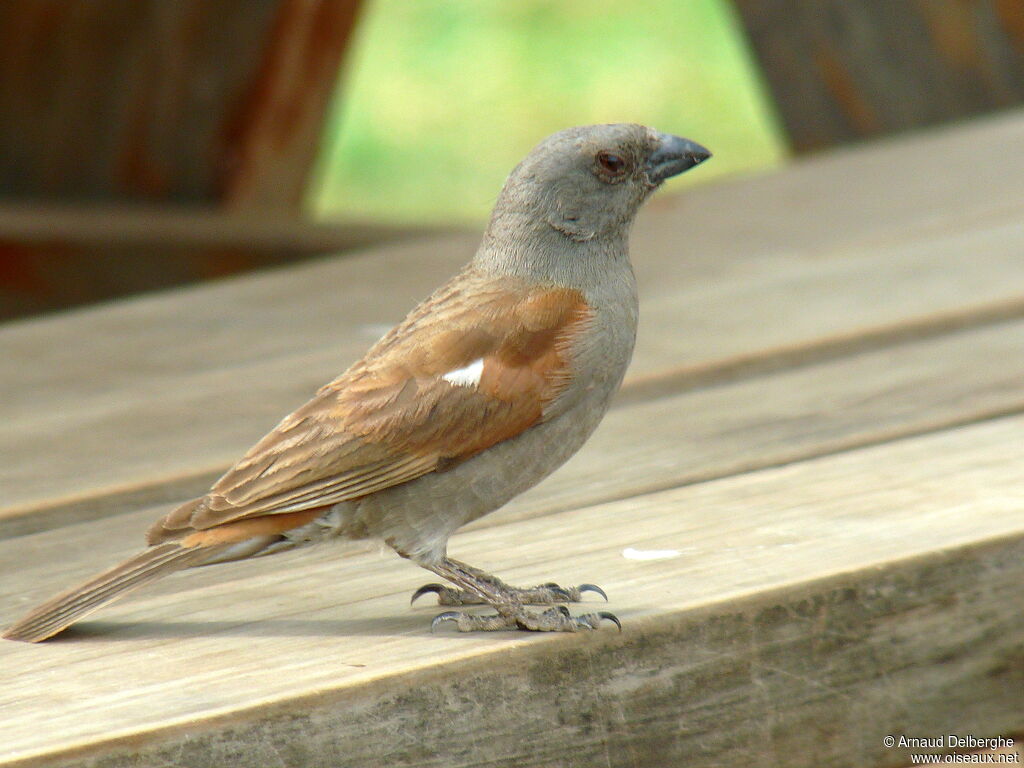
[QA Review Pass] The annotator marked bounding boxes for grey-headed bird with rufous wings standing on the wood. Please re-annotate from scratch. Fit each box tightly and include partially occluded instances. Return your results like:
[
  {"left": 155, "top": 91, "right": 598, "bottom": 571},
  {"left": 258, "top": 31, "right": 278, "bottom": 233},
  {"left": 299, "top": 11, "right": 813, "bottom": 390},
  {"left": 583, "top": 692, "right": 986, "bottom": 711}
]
[{"left": 2, "top": 123, "right": 711, "bottom": 642}]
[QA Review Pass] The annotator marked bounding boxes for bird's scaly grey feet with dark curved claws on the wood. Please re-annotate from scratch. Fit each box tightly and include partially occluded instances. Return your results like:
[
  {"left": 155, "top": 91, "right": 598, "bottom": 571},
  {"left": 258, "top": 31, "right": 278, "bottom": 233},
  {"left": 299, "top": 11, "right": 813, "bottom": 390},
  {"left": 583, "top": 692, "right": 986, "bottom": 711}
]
[{"left": 413, "top": 557, "right": 622, "bottom": 632}]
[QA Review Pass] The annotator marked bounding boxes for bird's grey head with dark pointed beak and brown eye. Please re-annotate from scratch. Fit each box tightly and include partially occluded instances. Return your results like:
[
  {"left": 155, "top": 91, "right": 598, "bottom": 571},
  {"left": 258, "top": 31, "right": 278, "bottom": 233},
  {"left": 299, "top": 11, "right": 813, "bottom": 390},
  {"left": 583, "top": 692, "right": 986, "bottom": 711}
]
[{"left": 488, "top": 123, "right": 711, "bottom": 242}]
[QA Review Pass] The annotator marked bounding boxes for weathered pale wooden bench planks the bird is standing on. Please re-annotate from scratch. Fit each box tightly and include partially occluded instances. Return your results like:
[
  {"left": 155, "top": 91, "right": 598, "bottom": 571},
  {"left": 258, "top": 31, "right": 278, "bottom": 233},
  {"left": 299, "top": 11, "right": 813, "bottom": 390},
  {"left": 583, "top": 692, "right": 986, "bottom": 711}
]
[{"left": 0, "top": 113, "right": 1024, "bottom": 766}]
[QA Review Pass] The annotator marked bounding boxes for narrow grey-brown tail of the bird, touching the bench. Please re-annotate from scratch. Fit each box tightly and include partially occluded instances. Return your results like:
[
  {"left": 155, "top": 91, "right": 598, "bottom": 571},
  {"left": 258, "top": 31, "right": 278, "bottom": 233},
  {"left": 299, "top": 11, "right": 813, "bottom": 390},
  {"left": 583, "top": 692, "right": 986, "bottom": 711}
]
[{"left": 0, "top": 543, "right": 223, "bottom": 643}]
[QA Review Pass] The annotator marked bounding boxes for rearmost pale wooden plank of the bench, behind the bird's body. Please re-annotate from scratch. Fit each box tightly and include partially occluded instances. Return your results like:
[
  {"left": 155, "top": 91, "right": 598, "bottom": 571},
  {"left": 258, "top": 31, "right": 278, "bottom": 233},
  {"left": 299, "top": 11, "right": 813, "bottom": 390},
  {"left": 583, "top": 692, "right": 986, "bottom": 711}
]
[{"left": 0, "top": 114, "right": 1024, "bottom": 530}]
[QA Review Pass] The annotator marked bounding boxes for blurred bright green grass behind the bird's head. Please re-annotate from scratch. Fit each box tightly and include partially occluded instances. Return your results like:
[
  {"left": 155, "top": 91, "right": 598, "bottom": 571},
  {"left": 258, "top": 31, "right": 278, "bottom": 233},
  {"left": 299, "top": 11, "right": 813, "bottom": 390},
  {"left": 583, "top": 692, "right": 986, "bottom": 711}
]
[{"left": 309, "top": 0, "right": 786, "bottom": 222}]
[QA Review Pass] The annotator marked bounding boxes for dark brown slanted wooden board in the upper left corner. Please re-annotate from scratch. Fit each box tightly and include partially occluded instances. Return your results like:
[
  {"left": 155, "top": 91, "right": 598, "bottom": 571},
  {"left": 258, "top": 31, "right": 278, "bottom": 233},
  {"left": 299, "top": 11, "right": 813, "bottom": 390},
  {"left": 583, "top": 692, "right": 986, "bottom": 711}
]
[{"left": 0, "top": 0, "right": 358, "bottom": 208}]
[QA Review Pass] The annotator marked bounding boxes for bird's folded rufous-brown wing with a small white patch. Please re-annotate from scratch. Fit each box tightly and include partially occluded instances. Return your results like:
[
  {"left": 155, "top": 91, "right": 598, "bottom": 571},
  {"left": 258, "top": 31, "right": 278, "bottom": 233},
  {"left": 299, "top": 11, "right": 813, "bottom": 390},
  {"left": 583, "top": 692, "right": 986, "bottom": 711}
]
[{"left": 148, "top": 273, "right": 592, "bottom": 544}]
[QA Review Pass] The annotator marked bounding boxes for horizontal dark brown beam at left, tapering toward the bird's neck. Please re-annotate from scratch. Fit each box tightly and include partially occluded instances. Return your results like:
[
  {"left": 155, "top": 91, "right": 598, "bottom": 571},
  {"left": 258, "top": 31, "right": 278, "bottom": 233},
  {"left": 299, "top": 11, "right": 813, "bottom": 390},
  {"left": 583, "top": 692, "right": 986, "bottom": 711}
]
[{"left": 0, "top": 204, "right": 453, "bottom": 321}]
